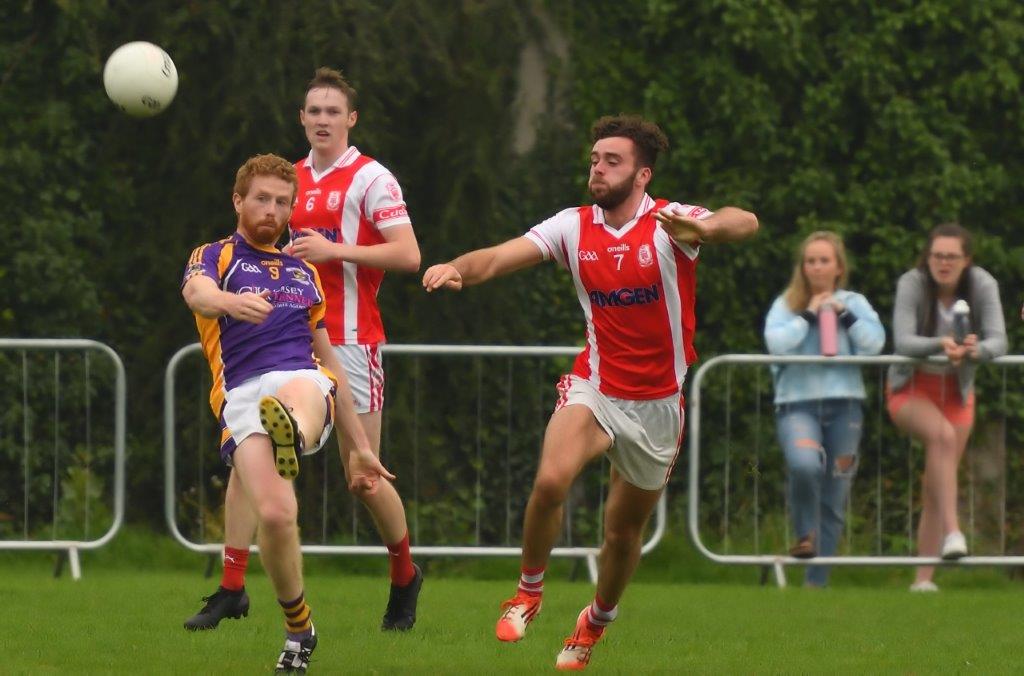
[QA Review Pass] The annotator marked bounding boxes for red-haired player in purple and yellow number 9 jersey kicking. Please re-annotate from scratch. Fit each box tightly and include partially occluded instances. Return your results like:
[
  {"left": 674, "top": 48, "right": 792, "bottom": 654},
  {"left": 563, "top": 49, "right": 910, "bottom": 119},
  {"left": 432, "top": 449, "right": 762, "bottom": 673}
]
[{"left": 181, "top": 155, "right": 394, "bottom": 673}]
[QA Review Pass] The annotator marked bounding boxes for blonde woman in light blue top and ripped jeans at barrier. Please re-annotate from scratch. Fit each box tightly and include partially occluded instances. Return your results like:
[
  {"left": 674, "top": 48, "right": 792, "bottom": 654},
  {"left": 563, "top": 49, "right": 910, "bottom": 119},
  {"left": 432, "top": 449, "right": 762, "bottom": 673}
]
[{"left": 765, "top": 231, "right": 886, "bottom": 587}]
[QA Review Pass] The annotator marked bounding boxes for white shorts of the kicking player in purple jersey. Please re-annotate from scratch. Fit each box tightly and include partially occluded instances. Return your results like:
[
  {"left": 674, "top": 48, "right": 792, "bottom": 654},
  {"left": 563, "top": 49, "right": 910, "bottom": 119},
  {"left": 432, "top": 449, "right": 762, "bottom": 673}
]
[{"left": 220, "top": 369, "right": 334, "bottom": 465}]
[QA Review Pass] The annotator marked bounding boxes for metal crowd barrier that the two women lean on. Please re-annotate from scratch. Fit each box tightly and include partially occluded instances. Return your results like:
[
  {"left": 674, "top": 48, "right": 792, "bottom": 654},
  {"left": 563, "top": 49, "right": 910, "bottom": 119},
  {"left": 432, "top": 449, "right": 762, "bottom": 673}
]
[{"left": 687, "top": 354, "right": 1024, "bottom": 587}]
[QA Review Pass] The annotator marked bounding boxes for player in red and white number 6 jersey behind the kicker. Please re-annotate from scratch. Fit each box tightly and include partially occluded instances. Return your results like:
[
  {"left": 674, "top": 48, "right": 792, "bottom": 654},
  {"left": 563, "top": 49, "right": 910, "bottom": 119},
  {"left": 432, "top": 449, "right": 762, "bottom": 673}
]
[{"left": 288, "top": 69, "right": 423, "bottom": 631}]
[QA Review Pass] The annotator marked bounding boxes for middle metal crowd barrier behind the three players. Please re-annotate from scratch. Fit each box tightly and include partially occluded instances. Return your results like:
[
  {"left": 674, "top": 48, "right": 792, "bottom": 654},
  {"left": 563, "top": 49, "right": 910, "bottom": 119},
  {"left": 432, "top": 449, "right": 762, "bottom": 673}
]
[{"left": 164, "top": 343, "right": 667, "bottom": 580}]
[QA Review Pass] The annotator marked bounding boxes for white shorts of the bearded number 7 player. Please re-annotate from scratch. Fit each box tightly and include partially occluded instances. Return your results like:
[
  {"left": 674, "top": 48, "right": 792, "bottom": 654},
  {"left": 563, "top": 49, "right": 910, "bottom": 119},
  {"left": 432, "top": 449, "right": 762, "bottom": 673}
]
[{"left": 555, "top": 375, "right": 685, "bottom": 491}]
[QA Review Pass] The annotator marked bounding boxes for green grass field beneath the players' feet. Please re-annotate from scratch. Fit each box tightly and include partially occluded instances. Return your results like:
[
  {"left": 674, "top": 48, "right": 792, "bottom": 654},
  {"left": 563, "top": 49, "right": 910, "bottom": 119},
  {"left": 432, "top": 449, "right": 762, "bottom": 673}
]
[{"left": 0, "top": 555, "right": 1022, "bottom": 674}]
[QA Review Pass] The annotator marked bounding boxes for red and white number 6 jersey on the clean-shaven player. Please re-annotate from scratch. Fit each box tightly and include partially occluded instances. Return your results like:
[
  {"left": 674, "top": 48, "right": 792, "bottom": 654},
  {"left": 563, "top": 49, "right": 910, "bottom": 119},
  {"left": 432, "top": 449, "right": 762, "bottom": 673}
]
[{"left": 289, "top": 145, "right": 412, "bottom": 345}]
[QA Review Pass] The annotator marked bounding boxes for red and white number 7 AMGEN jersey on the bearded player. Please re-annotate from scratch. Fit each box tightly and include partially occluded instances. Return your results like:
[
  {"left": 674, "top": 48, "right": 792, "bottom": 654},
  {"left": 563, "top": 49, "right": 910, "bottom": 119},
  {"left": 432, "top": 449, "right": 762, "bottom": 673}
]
[{"left": 525, "top": 195, "right": 712, "bottom": 399}]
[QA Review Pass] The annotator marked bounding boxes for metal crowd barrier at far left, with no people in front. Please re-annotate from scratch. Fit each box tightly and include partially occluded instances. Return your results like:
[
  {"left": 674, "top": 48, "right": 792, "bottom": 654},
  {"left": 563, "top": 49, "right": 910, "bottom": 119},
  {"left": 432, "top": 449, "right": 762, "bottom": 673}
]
[{"left": 0, "top": 338, "right": 126, "bottom": 580}]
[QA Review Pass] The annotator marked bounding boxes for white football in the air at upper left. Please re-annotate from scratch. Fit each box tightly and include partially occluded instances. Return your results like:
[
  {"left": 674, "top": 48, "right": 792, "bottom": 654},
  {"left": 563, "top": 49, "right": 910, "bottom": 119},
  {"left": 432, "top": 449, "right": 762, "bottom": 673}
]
[{"left": 103, "top": 42, "right": 178, "bottom": 118}]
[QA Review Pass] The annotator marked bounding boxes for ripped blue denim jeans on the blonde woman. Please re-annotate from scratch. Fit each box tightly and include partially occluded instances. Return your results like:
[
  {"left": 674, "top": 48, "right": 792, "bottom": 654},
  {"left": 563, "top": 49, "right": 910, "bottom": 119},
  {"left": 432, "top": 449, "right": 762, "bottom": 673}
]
[{"left": 775, "top": 399, "right": 864, "bottom": 586}]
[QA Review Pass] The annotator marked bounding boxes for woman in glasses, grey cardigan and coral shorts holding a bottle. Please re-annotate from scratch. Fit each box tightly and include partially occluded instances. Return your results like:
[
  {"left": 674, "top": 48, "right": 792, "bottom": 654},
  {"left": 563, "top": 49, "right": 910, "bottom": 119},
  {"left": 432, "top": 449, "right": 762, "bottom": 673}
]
[{"left": 888, "top": 223, "right": 1007, "bottom": 591}]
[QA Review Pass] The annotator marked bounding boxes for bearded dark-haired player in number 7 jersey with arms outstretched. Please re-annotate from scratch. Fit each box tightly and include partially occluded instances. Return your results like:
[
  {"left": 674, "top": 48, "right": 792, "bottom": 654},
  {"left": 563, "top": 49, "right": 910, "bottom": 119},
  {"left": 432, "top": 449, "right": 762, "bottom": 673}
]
[{"left": 423, "top": 116, "right": 758, "bottom": 671}]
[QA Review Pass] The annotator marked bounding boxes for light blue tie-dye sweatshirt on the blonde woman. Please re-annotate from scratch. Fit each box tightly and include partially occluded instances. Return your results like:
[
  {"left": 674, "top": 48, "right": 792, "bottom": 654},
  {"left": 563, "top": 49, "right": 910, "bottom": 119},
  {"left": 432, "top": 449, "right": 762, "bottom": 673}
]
[{"left": 765, "top": 289, "right": 886, "bottom": 404}]
